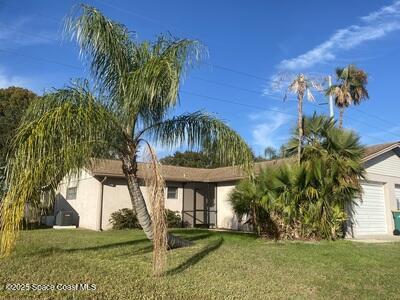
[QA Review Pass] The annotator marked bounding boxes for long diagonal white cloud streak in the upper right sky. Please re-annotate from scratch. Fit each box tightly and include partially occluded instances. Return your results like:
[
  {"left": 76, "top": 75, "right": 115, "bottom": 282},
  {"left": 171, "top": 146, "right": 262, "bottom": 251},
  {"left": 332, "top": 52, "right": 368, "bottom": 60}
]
[{"left": 278, "top": 0, "right": 400, "bottom": 71}]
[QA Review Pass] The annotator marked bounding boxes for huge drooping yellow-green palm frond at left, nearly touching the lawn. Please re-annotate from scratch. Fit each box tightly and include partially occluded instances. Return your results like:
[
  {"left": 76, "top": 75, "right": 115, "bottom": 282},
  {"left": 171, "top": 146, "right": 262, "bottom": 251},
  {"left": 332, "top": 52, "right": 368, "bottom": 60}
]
[{"left": 0, "top": 82, "right": 123, "bottom": 254}]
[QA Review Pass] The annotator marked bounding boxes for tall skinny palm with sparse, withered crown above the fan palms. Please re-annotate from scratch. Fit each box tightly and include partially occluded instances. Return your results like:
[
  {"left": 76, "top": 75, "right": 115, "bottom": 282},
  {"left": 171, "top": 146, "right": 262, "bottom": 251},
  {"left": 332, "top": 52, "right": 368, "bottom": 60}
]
[{"left": 285, "top": 74, "right": 319, "bottom": 164}]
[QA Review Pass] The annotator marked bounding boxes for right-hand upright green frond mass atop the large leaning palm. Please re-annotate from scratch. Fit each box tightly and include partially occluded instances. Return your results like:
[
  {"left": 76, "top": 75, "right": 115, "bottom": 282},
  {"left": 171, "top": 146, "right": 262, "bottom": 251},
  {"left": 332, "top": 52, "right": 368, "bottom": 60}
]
[{"left": 121, "top": 36, "right": 206, "bottom": 127}]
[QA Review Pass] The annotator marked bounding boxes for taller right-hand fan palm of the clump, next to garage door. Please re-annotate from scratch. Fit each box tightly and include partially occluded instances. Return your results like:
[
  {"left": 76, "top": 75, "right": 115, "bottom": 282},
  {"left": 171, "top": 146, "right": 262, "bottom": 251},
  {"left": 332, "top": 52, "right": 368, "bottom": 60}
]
[{"left": 282, "top": 114, "right": 364, "bottom": 238}]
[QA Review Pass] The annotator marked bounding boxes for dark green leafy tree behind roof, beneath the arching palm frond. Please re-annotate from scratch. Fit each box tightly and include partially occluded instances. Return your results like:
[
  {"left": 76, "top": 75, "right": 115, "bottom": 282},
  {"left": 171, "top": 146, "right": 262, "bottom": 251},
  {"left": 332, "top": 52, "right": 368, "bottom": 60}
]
[{"left": 160, "top": 151, "right": 224, "bottom": 169}]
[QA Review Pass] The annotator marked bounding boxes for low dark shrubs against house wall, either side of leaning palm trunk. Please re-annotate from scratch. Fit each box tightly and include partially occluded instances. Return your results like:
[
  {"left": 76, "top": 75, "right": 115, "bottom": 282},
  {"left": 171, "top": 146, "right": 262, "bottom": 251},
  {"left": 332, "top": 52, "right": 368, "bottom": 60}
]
[{"left": 110, "top": 208, "right": 182, "bottom": 230}]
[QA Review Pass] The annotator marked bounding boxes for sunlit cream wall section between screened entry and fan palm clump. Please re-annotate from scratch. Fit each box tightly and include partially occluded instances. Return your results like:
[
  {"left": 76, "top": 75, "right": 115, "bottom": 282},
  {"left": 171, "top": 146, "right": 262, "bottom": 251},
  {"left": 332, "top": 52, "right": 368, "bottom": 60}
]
[{"left": 217, "top": 181, "right": 239, "bottom": 229}]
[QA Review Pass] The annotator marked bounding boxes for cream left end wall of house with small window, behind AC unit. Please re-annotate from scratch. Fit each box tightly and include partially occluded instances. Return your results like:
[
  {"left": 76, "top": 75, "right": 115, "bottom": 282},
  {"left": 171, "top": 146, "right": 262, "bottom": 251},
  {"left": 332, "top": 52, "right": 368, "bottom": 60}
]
[{"left": 54, "top": 170, "right": 101, "bottom": 230}]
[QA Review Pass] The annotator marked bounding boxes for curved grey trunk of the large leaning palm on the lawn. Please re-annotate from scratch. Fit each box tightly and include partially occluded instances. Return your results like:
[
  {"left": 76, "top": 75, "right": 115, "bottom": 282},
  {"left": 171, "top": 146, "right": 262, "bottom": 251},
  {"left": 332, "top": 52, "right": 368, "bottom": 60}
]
[{"left": 123, "top": 157, "right": 192, "bottom": 249}]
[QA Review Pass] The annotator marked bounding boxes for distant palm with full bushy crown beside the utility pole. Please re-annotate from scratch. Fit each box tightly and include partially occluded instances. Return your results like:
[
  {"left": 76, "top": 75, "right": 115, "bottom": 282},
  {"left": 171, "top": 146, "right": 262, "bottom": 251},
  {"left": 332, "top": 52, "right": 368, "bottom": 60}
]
[{"left": 326, "top": 65, "right": 369, "bottom": 128}]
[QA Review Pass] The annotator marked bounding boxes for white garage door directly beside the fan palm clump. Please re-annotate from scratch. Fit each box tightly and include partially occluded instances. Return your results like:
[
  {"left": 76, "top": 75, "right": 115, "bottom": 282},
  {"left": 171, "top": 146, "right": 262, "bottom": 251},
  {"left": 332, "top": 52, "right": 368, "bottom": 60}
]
[{"left": 353, "top": 184, "right": 387, "bottom": 236}]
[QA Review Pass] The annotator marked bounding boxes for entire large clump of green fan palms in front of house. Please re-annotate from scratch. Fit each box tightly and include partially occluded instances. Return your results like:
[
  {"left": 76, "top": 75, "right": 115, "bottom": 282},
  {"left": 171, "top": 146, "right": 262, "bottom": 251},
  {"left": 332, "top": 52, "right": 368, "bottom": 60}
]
[{"left": 230, "top": 114, "right": 364, "bottom": 239}]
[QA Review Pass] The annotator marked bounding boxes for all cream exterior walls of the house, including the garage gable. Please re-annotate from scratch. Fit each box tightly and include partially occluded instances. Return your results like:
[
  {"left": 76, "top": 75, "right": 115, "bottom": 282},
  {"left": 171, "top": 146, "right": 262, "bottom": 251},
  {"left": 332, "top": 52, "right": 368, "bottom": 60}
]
[{"left": 55, "top": 151, "right": 400, "bottom": 233}]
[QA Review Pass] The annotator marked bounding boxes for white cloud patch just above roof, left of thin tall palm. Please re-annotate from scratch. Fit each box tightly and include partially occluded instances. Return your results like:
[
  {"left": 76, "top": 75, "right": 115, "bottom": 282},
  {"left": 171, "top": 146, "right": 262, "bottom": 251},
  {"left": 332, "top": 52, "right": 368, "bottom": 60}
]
[{"left": 248, "top": 111, "right": 293, "bottom": 152}]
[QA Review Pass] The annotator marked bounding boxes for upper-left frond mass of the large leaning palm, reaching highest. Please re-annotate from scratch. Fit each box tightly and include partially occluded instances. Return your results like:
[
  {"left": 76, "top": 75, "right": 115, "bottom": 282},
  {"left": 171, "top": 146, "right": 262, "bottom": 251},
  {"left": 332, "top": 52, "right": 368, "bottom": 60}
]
[{"left": 65, "top": 5, "right": 135, "bottom": 105}]
